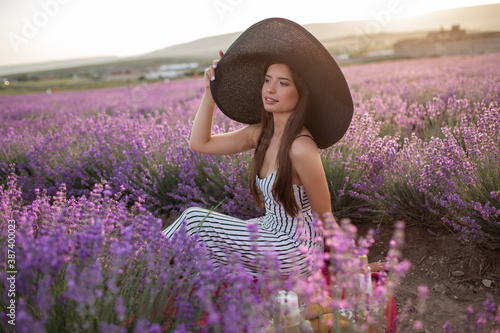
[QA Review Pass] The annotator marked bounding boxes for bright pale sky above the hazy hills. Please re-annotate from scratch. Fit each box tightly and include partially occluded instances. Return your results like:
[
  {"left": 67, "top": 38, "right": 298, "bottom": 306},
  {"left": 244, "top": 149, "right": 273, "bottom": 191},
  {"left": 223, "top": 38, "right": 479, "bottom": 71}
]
[{"left": 0, "top": 0, "right": 500, "bottom": 66}]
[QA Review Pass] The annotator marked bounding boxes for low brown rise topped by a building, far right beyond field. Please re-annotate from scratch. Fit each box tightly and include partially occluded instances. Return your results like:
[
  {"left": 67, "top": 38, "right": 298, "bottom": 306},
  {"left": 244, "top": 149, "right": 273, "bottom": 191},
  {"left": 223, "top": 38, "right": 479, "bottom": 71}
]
[{"left": 394, "top": 25, "right": 500, "bottom": 58}]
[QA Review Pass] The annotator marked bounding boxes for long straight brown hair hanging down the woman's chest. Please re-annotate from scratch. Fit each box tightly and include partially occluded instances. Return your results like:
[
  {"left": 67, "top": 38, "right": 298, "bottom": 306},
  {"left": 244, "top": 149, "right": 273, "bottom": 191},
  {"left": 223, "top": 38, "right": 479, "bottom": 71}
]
[{"left": 249, "top": 62, "right": 309, "bottom": 216}]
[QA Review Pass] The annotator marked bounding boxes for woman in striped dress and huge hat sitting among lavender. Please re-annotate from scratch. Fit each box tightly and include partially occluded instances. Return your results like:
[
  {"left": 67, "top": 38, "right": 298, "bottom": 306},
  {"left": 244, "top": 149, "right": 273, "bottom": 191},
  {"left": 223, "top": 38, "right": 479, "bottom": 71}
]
[{"left": 164, "top": 18, "right": 353, "bottom": 276}]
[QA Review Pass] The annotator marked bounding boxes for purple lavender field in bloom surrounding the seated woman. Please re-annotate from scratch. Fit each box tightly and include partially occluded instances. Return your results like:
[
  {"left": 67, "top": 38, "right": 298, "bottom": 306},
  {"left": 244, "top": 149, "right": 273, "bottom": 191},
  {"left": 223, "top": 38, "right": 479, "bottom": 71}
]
[{"left": 0, "top": 54, "right": 500, "bottom": 332}]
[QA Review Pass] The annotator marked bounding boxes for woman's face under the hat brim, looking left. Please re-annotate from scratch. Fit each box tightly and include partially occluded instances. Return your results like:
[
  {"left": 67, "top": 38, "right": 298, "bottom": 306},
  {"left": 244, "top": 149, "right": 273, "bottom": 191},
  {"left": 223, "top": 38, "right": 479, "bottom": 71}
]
[{"left": 262, "top": 64, "right": 299, "bottom": 113}]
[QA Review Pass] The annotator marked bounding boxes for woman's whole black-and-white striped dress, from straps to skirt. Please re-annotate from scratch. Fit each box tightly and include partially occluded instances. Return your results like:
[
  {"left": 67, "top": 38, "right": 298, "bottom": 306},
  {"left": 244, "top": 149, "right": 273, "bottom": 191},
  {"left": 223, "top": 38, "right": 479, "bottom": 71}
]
[{"left": 163, "top": 171, "right": 323, "bottom": 277}]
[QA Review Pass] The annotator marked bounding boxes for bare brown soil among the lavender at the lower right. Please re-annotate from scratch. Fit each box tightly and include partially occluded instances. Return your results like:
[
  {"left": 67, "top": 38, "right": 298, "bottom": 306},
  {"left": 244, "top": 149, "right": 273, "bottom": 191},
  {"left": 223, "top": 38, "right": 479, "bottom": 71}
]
[{"left": 357, "top": 220, "right": 500, "bottom": 333}]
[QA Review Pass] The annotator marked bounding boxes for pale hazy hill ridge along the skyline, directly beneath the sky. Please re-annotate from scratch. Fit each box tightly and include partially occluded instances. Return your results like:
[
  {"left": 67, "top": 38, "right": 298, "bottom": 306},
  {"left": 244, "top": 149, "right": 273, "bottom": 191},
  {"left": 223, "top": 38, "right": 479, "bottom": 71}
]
[{"left": 0, "top": 4, "right": 500, "bottom": 75}]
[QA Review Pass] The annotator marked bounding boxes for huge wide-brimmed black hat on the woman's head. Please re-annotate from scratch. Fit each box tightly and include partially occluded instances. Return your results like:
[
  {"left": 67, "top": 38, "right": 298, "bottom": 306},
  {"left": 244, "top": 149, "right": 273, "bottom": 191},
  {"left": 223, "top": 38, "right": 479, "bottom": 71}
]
[{"left": 210, "top": 18, "right": 353, "bottom": 148}]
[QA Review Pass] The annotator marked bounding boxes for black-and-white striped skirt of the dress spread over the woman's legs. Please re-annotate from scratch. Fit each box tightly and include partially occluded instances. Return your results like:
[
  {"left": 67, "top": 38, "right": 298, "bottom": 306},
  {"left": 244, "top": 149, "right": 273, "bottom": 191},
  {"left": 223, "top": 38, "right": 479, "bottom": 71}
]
[{"left": 163, "top": 207, "right": 323, "bottom": 277}]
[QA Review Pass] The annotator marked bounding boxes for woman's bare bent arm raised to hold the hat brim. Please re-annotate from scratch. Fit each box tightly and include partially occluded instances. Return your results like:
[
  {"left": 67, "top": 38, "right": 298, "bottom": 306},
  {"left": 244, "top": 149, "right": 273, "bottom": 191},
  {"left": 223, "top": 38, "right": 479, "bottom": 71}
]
[{"left": 189, "top": 51, "right": 260, "bottom": 155}]
